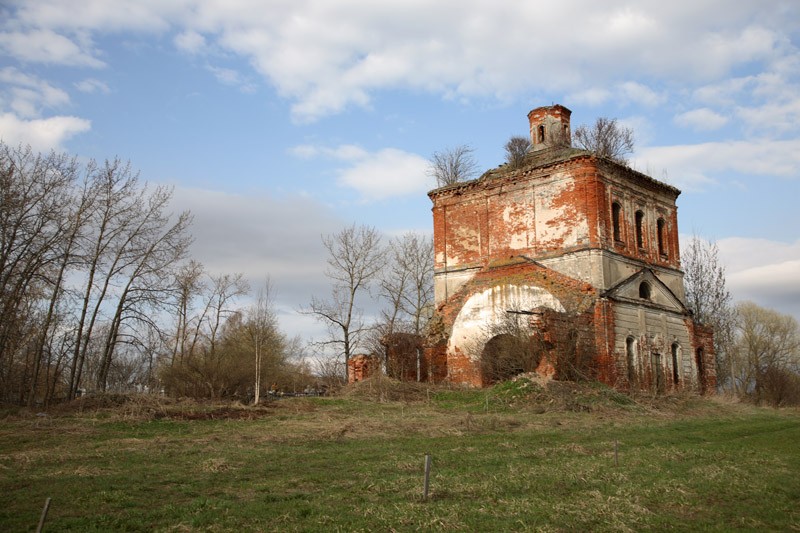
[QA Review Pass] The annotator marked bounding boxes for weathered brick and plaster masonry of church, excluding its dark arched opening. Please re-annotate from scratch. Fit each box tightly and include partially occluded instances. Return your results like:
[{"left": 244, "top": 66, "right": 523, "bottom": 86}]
[{"left": 426, "top": 106, "right": 714, "bottom": 390}]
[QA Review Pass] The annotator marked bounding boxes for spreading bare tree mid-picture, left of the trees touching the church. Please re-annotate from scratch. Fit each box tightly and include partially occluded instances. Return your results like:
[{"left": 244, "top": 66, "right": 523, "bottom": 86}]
[{"left": 301, "top": 224, "right": 383, "bottom": 376}]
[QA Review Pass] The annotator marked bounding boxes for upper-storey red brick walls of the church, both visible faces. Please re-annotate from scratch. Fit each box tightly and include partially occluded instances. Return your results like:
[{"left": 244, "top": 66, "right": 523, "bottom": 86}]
[{"left": 431, "top": 155, "right": 680, "bottom": 270}]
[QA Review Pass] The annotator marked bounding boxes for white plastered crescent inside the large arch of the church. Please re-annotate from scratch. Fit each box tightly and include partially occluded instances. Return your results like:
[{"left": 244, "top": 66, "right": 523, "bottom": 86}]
[{"left": 447, "top": 284, "right": 564, "bottom": 362}]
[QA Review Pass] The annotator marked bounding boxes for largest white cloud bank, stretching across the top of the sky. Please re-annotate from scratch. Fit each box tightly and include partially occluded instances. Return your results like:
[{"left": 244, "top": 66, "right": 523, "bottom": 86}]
[{"left": 5, "top": 0, "right": 800, "bottom": 121}]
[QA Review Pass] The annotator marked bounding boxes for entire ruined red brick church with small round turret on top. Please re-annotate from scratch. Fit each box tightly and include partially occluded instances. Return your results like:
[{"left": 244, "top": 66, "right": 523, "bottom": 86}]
[{"left": 417, "top": 105, "right": 716, "bottom": 392}]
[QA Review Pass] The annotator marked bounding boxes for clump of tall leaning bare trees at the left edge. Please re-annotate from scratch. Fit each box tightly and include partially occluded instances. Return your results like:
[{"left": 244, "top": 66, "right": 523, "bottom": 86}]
[{"left": 0, "top": 143, "right": 198, "bottom": 404}]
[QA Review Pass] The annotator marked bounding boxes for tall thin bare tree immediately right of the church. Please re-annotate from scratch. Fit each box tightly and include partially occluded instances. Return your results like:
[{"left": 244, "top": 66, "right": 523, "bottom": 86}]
[{"left": 681, "top": 235, "right": 737, "bottom": 392}]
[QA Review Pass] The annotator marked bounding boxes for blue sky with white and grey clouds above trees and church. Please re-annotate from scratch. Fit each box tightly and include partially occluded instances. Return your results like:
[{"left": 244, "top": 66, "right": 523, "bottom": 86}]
[{"left": 0, "top": 0, "right": 800, "bottom": 334}]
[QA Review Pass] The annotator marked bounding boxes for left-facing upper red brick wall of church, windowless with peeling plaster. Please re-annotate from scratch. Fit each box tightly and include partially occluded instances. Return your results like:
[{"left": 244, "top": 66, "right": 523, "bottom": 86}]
[{"left": 431, "top": 156, "right": 610, "bottom": 269}]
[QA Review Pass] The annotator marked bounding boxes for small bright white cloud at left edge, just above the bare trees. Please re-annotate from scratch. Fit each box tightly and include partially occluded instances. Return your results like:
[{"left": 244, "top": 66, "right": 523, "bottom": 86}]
[{"left": 0, "top": 113, "right": 91, "bottom": 152}]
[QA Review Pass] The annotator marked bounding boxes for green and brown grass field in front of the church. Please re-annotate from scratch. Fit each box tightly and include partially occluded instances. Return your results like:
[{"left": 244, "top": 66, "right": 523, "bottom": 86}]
[{"left": 0, "top": 380, "right": 800, "bottom": 531}]
